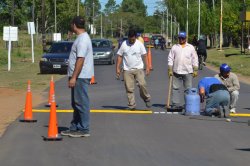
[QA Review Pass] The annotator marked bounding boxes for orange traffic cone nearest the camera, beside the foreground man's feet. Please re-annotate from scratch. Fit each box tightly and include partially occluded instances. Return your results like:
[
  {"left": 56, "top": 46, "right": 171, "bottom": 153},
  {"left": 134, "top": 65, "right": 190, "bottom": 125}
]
[{"left": 43, "top": 94, "right": 62, "bottom": 141}]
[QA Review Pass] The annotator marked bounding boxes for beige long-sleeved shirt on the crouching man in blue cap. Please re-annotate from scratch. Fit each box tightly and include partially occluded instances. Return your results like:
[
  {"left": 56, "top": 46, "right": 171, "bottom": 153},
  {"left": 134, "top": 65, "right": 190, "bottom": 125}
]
[{"left": 214, "top": 72, "right": 240, "bottom": 92}]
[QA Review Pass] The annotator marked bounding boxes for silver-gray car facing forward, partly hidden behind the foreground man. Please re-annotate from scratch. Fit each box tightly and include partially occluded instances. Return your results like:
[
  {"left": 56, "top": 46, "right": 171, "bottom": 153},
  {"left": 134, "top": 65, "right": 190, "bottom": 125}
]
[{"left": 92, "top": 39, "right": 115, "bottom": 65}]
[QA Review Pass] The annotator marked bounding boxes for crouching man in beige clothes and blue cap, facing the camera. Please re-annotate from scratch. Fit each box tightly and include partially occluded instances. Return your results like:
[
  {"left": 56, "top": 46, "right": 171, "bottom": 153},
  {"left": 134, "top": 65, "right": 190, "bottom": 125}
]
[{"left": 215, "top": 63, "right": 240, "bottom": 113}]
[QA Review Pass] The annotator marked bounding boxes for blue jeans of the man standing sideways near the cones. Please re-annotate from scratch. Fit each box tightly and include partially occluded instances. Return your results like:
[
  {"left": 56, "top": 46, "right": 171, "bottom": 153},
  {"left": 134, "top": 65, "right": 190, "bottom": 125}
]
[{"left": 69, "top": 78, "right": 90, "bottom": 132}]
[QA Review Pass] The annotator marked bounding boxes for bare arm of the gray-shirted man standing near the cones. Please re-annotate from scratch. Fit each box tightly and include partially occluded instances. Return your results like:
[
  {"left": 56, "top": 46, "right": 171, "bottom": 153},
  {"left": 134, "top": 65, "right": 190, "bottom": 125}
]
[{"left": 68, "top": 57, "right": 85, "bottom": 88}]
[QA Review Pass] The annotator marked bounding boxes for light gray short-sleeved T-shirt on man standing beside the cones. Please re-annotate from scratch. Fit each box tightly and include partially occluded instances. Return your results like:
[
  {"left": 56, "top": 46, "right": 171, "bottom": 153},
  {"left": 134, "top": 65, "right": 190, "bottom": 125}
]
[{"left": 68, "top": 32, "right": 94, "bottom": 78}]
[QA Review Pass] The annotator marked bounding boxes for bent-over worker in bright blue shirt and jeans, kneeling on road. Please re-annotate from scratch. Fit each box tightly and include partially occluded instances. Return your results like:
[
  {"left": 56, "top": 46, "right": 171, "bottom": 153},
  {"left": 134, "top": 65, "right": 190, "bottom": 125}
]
[{"left": 198, "top": 77, "right": 230, "bottom": 117}]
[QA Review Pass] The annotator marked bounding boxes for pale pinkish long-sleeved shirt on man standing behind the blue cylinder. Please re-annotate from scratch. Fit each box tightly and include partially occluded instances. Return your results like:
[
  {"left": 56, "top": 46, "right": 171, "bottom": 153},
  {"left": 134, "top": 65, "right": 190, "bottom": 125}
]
[{"left": 168, "top": 43, "right": 198, "bottom": 74}]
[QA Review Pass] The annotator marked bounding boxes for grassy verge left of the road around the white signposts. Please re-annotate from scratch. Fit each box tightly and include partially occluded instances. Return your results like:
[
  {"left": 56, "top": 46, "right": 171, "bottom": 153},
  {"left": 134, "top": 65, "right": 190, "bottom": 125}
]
[{"left": 0, "top": 31, "right": 65, "bottom": 91}]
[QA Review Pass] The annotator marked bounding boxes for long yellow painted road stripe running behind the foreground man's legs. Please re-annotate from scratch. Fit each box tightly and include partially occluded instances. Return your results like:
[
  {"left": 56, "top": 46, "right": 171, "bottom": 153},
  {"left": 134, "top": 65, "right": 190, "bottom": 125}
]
[{"left": 32, "top": 110, "right": 153, "bottom": 114}]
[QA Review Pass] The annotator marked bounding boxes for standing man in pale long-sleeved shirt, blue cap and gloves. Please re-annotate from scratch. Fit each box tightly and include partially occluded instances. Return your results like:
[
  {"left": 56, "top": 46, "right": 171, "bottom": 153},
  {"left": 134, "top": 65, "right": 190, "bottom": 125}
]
[{"left": 168, "top": 32, "right": 198, "bottom": 108}]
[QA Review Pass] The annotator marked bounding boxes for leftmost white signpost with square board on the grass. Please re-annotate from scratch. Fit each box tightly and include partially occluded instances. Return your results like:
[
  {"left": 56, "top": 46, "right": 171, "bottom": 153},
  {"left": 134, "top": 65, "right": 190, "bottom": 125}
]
[{"left": 3, "top": 26, "right": 18, "bottom": 71}]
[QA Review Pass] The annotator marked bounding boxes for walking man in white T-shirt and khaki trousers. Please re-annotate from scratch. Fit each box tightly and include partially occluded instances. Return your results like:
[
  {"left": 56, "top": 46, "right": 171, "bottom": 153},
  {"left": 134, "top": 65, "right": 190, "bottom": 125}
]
[{"left": 116, "top": 30, "right": 151, "bottom": 110}]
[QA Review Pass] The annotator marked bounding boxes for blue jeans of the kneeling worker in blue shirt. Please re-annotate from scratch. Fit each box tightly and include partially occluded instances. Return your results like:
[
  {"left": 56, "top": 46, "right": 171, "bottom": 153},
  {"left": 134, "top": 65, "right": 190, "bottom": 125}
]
[{"left": 206, "top": 90, "right": 230, "bottom": 115}]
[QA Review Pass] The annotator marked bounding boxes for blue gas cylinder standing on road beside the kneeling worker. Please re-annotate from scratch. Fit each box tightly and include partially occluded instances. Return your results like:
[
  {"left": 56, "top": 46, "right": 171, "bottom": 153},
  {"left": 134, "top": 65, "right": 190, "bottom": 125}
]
[{"left": 185, "top": 88, "right": 200, "bottom": 116}]
